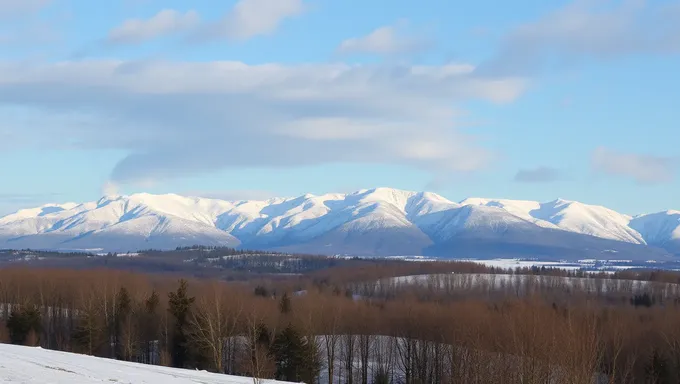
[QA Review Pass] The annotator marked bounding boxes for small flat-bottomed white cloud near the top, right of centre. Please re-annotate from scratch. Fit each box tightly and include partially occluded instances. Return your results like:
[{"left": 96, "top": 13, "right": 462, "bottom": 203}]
[{"left": 338, "top": 26, "right": 427, "bottom": 55}]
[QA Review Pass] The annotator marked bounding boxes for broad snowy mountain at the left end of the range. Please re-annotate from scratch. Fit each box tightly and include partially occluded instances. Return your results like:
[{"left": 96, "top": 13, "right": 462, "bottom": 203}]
[{"left": 0, "top": 194, "right": 239, "bottom": 251}]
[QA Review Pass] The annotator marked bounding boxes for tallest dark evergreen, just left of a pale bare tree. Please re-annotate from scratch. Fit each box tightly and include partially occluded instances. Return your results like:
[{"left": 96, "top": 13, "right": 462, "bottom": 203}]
[{"left": 168, "top": 279, "right": 196, "bottom": 368}]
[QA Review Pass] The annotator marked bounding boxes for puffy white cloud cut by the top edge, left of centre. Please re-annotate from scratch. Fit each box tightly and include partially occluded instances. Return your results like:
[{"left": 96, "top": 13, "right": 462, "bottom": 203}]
[{"left": 196, "top": 0, "right": 306, "bottom": 41}]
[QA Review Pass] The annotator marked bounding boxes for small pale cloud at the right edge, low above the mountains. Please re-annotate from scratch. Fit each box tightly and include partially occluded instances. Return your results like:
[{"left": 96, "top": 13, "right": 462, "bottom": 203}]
[{"left": 592, "top": 147, "right": 678, "bottom": 184}]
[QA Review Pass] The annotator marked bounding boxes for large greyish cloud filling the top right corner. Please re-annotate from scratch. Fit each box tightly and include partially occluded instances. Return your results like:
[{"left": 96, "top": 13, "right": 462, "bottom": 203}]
[{"left": 483, "top": 0, "right": 680, "bottom": 73}]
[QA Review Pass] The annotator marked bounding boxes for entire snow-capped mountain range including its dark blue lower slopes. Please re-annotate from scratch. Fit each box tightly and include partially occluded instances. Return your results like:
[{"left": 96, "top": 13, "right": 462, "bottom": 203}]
[{"left": 0, "top": 188, "right": 680, "bottom": 260}]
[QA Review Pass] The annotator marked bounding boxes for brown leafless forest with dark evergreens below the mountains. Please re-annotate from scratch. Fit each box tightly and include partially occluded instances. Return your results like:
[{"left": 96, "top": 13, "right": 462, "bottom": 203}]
[{"left": 0, "top": 250, "right": 680, "bottom": 384}]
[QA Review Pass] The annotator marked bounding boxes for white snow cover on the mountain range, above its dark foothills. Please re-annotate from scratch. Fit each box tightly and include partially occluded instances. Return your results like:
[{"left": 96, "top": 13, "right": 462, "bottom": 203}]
[{"left": 0, "top": 188, "right": 680, "bottom": 252}]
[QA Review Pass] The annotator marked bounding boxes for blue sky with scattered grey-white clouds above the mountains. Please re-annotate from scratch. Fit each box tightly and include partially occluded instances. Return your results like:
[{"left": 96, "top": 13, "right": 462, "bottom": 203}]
[{"left": 0, "top": 0, "right": 680, "bottom": 214}]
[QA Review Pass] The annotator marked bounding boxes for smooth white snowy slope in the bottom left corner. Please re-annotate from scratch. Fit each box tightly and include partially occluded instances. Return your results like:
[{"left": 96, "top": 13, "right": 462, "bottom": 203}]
[{"left": 0, "top": 344, "right": 285, "bottom": 384}]
